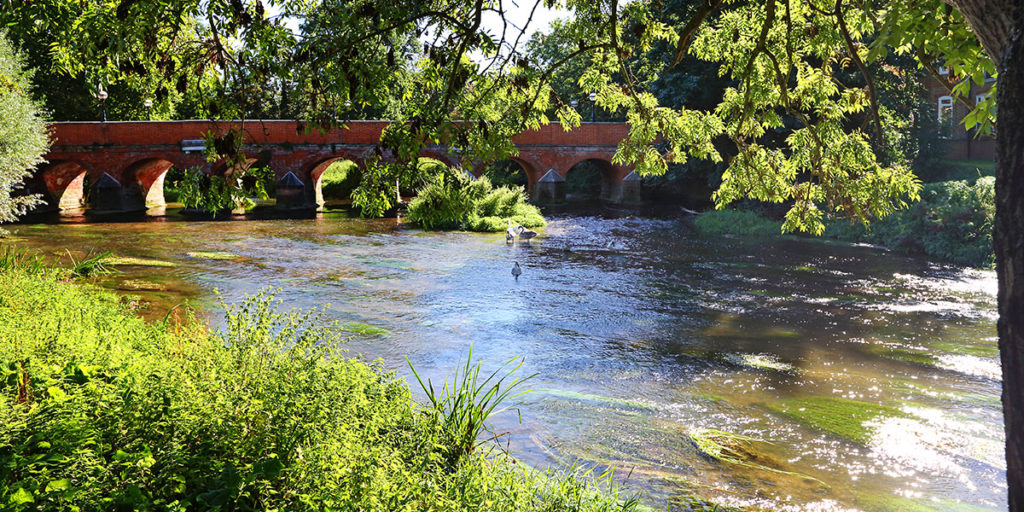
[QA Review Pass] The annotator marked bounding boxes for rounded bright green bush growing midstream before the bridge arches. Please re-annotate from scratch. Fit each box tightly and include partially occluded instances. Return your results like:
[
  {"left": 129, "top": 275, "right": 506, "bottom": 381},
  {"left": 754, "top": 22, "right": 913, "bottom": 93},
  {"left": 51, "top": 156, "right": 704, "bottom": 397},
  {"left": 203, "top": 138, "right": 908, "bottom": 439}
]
[{"left": 409, "top": 172, "right": 547, "bottom": 231}]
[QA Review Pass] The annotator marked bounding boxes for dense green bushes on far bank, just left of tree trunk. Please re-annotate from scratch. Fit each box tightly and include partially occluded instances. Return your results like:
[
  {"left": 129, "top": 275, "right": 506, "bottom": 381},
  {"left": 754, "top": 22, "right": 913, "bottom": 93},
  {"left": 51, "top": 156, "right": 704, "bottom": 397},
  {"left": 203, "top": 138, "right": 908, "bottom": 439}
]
[{"left": 824, "top": 176, "right": 995, "bottom": 266}]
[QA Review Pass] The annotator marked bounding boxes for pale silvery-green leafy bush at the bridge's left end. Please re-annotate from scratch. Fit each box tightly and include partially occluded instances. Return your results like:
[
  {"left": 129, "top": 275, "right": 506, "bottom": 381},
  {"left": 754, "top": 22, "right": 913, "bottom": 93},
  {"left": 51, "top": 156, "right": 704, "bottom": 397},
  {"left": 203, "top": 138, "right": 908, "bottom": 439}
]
[{"left": 0, "top": 31, "right": 50, "bottom": 225}]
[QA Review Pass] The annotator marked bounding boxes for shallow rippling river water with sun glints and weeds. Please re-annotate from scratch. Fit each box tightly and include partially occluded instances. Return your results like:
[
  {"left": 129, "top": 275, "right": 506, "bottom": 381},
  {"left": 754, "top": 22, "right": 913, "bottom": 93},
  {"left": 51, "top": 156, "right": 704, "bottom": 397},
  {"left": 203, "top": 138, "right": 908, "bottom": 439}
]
[{"left": 4, "top": 204, "right": 1006, "bottom": 512}]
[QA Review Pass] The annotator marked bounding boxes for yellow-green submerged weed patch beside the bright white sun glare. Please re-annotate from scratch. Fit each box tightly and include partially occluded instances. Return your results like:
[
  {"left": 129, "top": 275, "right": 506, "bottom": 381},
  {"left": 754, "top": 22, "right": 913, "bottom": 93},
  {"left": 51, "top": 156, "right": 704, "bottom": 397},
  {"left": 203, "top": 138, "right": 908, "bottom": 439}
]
[{"left": 768, "top": 396, "right": 907, "bottom": 444}]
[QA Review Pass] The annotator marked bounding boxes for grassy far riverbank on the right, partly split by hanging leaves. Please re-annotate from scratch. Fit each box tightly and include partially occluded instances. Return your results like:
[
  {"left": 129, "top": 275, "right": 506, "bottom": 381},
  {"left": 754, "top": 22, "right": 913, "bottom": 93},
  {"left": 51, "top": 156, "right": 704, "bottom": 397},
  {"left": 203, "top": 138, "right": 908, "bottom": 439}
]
[{"left": 694, "top": 177, "right": 995, "bottom": 268}]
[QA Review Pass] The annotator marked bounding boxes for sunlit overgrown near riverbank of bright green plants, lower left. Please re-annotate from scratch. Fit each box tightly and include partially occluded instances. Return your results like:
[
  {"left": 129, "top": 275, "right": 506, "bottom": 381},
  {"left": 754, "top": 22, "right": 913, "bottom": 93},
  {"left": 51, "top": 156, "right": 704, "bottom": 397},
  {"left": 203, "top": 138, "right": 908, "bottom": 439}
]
[{"left": 0, "top": 262, "right": 637, "bottom": 511}]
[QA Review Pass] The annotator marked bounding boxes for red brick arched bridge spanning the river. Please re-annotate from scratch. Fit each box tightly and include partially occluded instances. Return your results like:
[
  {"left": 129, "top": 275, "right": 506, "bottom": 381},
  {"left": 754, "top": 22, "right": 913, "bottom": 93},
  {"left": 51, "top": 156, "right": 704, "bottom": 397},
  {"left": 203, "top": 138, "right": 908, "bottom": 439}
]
[{"left": 29, "top": 121, "right": 637, "bottom": 211}]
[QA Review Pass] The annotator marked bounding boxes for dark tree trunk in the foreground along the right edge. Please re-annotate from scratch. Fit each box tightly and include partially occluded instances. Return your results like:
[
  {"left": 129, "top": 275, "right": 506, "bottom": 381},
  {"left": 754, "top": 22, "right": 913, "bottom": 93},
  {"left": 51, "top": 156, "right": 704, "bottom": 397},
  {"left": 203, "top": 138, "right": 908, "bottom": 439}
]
[{"left": 993, "top": 8, "right": 1024, "bottom": 512}]
